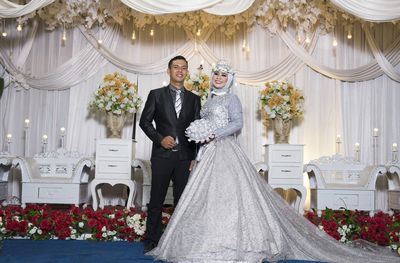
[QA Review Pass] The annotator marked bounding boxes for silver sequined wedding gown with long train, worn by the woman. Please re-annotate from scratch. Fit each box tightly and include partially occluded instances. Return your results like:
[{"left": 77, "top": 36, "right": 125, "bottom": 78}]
[{"left": 148, "top": 94, "right": 400, "bottom": 262}]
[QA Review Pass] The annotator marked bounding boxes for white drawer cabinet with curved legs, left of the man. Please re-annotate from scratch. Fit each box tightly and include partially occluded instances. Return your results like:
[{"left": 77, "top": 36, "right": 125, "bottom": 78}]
[{"left": 90, "top": 139, "right": 136, "bottom": 210}]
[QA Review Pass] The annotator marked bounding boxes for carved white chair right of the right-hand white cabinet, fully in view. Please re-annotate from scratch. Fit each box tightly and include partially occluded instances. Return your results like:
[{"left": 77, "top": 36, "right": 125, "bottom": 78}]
[{"left": 304, "top": 155, "right": 386, "bottom": 215}]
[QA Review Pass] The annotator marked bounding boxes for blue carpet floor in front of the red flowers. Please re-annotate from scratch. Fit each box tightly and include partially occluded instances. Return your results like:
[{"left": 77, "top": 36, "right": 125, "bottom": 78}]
[{"left": 0, "top": 239, "right": 324, "bottom": 263}]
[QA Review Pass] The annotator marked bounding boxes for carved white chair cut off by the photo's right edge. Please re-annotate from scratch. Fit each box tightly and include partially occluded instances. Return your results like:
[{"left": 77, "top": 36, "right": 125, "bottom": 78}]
[{"left": 386, "top": 163, "right": 400, "bottom": 209}]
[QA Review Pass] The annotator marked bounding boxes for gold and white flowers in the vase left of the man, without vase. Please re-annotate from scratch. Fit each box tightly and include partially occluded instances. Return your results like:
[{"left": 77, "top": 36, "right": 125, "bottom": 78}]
[{"left": 89, "top": 72, "right": 142, "bottom": 115}]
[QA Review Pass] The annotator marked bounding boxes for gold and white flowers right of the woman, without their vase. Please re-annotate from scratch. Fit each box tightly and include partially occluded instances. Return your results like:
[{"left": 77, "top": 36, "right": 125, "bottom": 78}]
[{"left": 260, "top": 80, "right": 304, "bottom": 124}]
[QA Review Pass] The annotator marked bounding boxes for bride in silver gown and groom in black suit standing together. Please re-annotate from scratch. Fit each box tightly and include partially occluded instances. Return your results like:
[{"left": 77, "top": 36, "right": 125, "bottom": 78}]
[{"left": 140, "top": 57, "right": 400, "bottom": 262}]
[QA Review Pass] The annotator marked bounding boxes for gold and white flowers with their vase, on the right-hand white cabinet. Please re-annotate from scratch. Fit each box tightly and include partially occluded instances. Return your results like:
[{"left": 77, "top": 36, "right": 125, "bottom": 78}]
[{"left": 260, "top": 80, "right": 304, "bottom": 143}]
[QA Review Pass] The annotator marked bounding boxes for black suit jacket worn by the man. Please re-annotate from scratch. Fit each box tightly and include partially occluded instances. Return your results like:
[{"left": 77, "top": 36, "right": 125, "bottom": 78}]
[{"left": 139, "top": 86, "right": 201, "bottom": 160}]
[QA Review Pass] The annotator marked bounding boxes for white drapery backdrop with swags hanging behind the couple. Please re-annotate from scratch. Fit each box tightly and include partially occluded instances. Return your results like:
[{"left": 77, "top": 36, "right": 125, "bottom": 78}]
[{"left": 0, "top": 18, "right": 400, "bottom": 208}]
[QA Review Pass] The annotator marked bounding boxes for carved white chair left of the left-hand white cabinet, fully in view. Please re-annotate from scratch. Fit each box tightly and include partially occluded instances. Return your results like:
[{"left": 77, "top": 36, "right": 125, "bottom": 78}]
[{"left": 13, "top": 148, "right": 94, "bottom": 207}]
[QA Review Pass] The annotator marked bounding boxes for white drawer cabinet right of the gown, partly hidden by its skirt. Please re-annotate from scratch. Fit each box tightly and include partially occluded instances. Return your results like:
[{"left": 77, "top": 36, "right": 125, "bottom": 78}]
[{"left": 265, "top": 144, "right": 307, "bottom": 213}]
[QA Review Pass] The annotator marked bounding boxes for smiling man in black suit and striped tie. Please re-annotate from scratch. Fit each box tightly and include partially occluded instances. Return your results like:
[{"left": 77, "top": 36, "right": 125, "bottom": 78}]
[{"left": 139, "top": 56, "right": 200, "bottom": 253}]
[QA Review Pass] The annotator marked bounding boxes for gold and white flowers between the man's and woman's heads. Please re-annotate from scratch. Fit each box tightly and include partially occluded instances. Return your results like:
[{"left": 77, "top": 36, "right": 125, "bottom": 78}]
[{"left": 185, "top": 65, "right": 210, "bottom": 105}]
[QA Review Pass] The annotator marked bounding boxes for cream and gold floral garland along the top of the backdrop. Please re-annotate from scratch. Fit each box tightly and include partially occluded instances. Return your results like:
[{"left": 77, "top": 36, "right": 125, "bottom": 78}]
[{"left": 13, "top": 0, "right": 366, "bottom": 37}]
